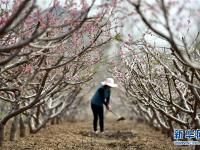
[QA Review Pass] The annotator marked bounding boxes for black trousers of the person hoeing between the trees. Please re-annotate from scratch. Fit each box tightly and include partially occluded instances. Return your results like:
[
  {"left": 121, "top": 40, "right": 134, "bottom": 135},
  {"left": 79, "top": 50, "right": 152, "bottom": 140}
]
[{"left": 91, "top": 104, "right": 104, "bottom": 132}]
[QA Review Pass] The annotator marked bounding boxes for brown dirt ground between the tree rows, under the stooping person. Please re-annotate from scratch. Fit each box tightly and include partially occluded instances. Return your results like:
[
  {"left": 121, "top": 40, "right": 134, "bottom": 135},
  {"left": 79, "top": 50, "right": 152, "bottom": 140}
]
[{"left": 4, "top": 121, "right": 192, "bottom": 150}]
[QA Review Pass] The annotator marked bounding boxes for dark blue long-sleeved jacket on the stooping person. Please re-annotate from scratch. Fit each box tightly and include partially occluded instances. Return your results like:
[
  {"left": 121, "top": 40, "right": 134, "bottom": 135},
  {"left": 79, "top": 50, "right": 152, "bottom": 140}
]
[{"left": 91, "top": 86, "right": 110, "bottom": 107}]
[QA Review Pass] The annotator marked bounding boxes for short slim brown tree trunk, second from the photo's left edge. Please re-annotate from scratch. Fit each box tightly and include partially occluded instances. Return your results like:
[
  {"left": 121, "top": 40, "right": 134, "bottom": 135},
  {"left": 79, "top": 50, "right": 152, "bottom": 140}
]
[{"left": 10, "top": 116, "right": 19, "bottom": 141}]
